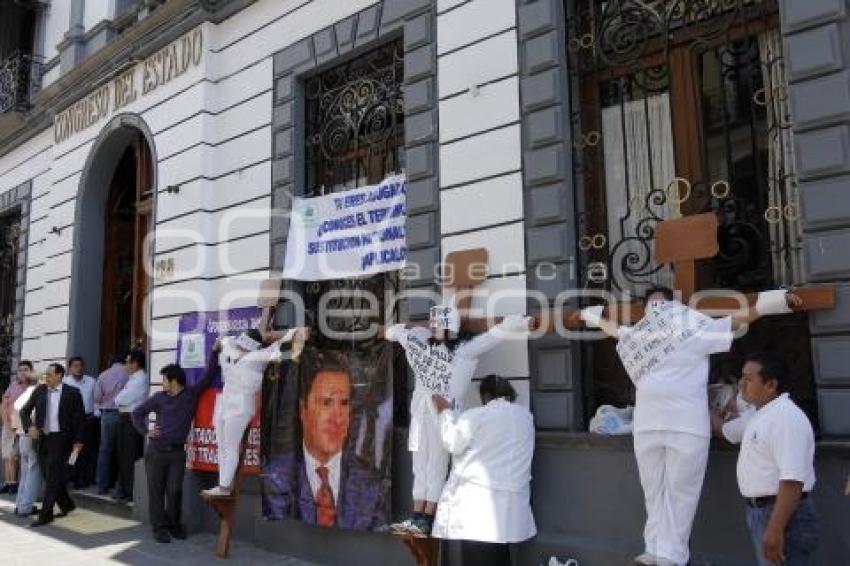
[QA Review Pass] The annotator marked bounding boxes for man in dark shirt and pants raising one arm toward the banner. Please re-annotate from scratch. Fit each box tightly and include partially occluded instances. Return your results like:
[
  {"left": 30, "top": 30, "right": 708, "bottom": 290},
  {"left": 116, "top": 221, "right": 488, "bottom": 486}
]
[{"left": 133, "top": 358, "right": 218, "bottom": 542}]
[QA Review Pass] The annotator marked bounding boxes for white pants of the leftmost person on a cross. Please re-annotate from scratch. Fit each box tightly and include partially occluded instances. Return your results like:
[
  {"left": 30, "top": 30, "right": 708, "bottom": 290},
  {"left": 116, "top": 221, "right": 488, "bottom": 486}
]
[{"left": 213, "top": 391, "right": 256, "bottom": 487}]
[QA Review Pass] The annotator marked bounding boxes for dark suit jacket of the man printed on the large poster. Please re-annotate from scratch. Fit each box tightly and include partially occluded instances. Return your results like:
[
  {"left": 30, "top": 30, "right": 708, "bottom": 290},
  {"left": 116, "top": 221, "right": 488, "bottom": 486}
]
[{"left": 263, "top": 450, "right": 387, "bottom": 531}]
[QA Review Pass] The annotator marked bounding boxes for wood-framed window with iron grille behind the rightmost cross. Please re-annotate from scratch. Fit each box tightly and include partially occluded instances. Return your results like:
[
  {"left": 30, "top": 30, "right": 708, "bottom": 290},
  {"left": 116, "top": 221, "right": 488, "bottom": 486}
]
[{"left": 567, "top": 0, "right": 814, "bottom": 424}]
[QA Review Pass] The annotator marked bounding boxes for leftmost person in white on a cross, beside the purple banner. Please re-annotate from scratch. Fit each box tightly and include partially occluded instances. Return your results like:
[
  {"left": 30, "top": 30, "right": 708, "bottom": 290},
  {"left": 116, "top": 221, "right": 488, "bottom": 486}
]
[{"left": 203, "top": 328, "right": 308, "bottom": 497}]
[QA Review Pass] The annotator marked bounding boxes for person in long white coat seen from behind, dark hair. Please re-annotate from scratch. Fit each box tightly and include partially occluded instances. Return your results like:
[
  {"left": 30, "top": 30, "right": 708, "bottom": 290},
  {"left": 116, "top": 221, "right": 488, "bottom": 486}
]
[{"left": 431, "top": 375, "right": 537, "bottom": 566}]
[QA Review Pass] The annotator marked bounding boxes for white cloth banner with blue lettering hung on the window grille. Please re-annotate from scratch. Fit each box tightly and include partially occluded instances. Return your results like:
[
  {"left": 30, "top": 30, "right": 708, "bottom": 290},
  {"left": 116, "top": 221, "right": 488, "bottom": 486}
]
[{"left": 283, "top": 175, "right": 407, "bottom": 281}]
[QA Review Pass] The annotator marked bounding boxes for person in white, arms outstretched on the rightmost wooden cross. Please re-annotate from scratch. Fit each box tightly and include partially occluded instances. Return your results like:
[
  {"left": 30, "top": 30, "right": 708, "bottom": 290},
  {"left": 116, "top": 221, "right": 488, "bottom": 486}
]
[{"left": 581, "top": 287, "right": 799, "bottom": 565}]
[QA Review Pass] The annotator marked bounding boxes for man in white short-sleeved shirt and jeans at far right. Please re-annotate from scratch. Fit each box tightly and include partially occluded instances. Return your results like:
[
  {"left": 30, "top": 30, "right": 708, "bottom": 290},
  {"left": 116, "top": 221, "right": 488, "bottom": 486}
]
[{"left": 726, "top": 353, "right": 820, "bottom": 566}]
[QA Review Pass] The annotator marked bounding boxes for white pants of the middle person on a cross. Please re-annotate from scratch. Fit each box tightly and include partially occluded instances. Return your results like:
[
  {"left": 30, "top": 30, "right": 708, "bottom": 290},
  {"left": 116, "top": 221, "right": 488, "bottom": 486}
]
[{"left": 411, "top": 407, "right": 449, "bottom": 503}]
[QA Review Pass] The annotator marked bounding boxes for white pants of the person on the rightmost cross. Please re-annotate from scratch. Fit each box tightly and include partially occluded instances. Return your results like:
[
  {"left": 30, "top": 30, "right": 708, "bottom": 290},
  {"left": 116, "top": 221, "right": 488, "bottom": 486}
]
[{"left": 634, "top": 431, "right": 710, "bottom": 564}]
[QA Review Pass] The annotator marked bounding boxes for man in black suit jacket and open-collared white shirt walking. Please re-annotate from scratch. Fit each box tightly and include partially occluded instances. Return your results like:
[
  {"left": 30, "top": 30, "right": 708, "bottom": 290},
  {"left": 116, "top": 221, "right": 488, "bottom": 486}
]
[{"left": 21, "top": 364, "right": 85, "bottom": 527}]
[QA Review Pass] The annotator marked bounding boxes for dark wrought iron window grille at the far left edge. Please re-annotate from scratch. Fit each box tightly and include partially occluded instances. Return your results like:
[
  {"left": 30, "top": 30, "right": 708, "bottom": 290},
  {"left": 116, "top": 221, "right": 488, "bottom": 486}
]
[{"left": 0, "top": 214, "right": 21, "bottom": 391}]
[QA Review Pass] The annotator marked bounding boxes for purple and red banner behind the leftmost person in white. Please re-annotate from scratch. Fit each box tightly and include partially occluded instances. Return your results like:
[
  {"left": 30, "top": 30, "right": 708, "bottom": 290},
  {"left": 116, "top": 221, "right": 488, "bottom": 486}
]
[{"left": 177, "top": 307, "right": 261, "bottom": 475}]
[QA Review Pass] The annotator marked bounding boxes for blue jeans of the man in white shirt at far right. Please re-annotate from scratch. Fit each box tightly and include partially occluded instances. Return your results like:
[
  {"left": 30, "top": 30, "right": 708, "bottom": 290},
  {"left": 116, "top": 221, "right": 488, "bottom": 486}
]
[{"left": 747, "top": 497, "right": 820, "bottom": 566}]
